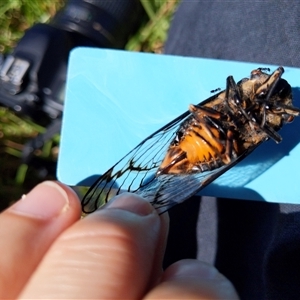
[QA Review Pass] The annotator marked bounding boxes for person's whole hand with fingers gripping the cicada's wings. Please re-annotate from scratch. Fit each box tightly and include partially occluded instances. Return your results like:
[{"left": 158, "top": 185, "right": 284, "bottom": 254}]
[{"left": 0, "top": 182, "right": 237, "bottom": 299}]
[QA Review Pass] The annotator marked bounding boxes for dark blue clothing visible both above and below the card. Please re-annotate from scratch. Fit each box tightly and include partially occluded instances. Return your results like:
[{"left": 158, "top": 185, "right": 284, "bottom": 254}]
[{"left": 165, "top": 1, "right": 300, "bottom": 299}]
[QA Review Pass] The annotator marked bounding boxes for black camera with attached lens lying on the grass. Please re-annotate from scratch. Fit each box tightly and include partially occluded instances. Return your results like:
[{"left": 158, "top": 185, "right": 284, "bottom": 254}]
[{"left": 0, "top": 0, "right": 145, "bottom": 126}]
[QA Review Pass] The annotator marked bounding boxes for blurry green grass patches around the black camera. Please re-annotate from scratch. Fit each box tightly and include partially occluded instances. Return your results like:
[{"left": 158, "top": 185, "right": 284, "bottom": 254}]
[{"left": 0, "top": 0, "right": 179, "bottom": 210}]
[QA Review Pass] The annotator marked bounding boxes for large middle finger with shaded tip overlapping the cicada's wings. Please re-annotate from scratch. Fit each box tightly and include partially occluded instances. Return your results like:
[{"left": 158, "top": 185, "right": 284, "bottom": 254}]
[{"left": 21, "top": 194, "right": 168, "bottom": 299}]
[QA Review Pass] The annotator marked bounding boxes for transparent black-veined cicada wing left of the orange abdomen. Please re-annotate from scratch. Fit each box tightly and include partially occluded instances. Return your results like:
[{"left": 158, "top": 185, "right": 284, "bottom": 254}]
[{"left": 81, "top": 112, "right": 190, "bottom": 214}]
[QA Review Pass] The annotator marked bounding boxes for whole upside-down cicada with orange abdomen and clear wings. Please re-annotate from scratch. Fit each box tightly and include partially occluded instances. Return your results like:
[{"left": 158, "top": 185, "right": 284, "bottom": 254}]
[{"left": 82, "top": 67, "right": 300, "bottom": 213}]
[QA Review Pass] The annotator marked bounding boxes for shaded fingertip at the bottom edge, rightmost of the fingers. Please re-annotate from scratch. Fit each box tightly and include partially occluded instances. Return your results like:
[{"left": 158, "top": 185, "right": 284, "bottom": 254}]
[{"left": 143, "top": 259, "right": 238, "bottom": 300}]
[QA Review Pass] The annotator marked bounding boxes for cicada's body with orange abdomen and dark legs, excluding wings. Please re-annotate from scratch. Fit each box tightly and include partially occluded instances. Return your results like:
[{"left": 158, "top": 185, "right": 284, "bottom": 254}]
[{"left": 157, "top": 68, "right": 299, "bottom": 175}]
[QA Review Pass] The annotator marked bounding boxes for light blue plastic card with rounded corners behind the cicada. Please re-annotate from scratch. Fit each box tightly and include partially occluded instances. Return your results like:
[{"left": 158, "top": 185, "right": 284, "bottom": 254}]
[{"left": 58, "top": 48, "right": 300, "bottom": 203}]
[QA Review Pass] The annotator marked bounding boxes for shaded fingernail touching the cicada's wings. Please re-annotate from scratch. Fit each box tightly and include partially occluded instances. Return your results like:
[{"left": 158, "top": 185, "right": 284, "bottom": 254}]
[{"left": 105, "top": 193, "right": 154, "bottom": 216}]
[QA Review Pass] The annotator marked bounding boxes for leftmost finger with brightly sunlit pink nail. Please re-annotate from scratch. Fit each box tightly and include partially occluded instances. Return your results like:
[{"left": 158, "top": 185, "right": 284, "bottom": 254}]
[{"left": 0, "top": 181, "right": 80, "bottom": 299}]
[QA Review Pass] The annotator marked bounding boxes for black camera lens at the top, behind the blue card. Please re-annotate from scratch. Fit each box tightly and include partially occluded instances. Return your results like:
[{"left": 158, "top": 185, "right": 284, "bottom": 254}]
[{"left": 52, "top": 0, "right": 145, "bottom": 48}]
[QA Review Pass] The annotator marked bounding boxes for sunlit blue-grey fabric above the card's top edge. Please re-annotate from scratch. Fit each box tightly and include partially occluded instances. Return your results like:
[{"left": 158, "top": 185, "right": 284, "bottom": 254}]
[{"left": 165, "top": 0, "right": 300, "bottom": 67}]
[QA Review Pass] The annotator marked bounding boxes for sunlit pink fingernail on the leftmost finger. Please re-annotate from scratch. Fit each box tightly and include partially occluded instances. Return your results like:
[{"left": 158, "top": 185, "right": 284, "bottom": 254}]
[{"left": 9, "top": 181, "right": 69, "bottom": 220}]
